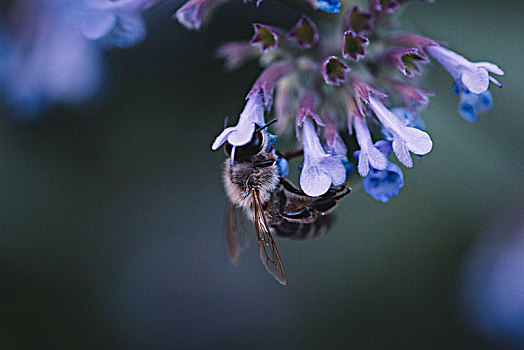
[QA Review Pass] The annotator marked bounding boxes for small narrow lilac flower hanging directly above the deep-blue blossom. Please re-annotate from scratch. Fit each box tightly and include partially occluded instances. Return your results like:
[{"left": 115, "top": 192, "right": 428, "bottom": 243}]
[{"left": 353, "top": 117, "right": 388, "bottom": 177}]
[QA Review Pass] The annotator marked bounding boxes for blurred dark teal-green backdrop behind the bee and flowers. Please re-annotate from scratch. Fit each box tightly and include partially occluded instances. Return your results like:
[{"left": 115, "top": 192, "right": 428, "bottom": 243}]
[{"left": 0, "top": 0, "right": 524, "bottom": 349}]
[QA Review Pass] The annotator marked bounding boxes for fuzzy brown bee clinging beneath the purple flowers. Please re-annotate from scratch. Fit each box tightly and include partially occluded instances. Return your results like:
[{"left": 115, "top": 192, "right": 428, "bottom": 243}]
[{"left": 219, "top": 122, "right": 351, "bottom": 285}]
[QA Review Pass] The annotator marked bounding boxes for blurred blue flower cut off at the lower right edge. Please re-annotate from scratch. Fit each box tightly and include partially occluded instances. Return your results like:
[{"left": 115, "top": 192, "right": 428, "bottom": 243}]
[{"left": 458, "top": 215, "right": 524, "bottom": 349}]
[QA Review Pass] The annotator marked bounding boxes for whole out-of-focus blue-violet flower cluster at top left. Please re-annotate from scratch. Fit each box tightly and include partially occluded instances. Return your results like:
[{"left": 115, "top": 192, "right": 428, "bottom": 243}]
[{"left": 0, "top": 0, "right": 162, "bottom": 117}]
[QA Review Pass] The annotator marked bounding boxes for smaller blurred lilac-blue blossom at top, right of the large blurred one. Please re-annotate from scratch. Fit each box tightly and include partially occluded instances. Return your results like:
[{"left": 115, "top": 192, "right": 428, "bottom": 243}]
[{"left": 79, "top": 0, "right": 162, "bottom": 48}]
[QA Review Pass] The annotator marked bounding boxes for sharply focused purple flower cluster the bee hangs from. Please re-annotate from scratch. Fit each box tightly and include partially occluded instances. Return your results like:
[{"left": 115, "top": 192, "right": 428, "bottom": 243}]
[{"left": 176, "top": 0, "right": 503, "bottom": 202}]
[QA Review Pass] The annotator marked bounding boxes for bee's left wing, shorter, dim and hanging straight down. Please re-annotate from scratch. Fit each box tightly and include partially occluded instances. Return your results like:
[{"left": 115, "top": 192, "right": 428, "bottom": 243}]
[{"left": 226, "top": 200, "right": 249, "bottom": 264}]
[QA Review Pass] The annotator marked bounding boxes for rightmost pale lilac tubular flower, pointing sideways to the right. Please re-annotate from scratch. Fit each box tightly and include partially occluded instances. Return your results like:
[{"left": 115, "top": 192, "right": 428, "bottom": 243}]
[{"left": 426, "top": 45, "right": 504, "bottom": 94}]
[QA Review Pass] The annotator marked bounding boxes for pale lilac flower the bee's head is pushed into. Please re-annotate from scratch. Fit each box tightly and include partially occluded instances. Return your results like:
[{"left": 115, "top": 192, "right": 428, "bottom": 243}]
[{"left": 211, "top": 92, "right": 264, "bottom": 152}]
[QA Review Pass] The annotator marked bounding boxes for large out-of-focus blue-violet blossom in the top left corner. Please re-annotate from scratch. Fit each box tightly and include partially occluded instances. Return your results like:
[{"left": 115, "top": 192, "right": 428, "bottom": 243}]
[{"left": 0, "top": 0, "right": 102, "bottom": 118}]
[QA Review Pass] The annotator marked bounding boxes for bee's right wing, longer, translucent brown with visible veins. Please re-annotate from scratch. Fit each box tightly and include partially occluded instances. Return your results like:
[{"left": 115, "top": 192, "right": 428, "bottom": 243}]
[{"left": 251, "top": 188, "right": 286, "bottom": 285}]
